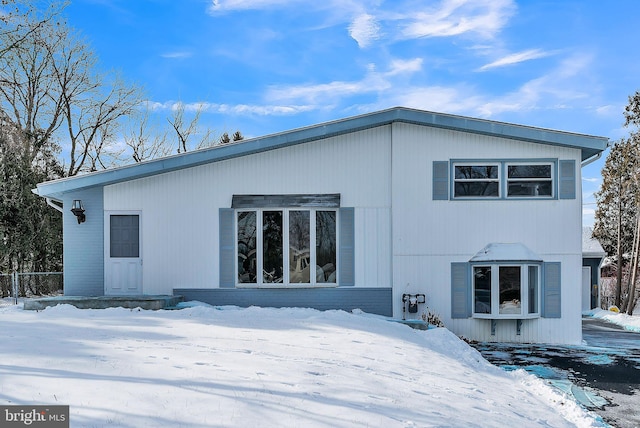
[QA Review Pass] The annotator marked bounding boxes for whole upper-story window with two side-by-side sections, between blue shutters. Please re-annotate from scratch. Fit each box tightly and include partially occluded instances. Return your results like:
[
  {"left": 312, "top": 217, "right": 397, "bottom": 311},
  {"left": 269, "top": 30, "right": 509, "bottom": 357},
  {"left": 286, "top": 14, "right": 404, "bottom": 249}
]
[{"left": 453, "top": 161, "right": 556, "bottom": 199}]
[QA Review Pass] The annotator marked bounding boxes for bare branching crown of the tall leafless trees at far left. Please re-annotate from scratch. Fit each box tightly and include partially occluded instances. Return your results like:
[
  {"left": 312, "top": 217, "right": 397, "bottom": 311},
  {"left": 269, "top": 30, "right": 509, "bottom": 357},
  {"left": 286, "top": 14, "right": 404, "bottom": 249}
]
[{"left": 0, "top": 2, "right": 140, "bottom": 176}]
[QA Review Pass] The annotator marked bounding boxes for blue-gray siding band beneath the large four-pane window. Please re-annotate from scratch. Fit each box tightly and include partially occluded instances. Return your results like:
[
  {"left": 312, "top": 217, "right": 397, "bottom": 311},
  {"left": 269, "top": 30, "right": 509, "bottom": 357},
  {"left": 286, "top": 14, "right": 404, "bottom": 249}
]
[{"left": 173, "top": 287, "right": 393, "bottom": 317}]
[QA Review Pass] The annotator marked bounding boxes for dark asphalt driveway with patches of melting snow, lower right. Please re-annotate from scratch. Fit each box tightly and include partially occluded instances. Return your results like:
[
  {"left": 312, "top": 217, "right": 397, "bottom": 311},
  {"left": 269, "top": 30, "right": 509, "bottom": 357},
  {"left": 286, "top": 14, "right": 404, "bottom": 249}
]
[{"left": 472, "top": 318, "right": 640, "bottom": 428}]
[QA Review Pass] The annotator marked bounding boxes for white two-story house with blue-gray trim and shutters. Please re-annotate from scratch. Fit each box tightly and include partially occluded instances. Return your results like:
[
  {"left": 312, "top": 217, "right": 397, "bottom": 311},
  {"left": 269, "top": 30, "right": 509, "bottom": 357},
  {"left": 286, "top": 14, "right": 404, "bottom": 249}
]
[{"left": 36, "top": 108, "right": 608, "bottom": 343}]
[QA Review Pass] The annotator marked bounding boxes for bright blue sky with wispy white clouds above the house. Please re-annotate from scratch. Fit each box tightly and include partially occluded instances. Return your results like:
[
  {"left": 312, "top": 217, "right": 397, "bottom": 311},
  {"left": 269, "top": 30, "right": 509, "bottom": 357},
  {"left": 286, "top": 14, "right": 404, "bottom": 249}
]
[{"left": 65, "top": 0, "right": 640, "bottom": 224}]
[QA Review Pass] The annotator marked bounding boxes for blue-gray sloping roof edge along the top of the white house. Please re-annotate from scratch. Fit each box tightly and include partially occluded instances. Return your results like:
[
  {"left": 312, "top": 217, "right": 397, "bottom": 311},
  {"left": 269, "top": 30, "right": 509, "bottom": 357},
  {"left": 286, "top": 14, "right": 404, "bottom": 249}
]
[{"left": 34, "top": 107, "right": 608, "bottom": 199}]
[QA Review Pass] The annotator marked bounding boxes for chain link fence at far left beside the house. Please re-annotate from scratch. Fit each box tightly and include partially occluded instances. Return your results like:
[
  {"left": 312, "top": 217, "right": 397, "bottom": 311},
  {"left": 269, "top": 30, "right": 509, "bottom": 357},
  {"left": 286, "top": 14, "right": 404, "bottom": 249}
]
[{"left": 0, "top": 272, "right": 64, "bottom": 299}]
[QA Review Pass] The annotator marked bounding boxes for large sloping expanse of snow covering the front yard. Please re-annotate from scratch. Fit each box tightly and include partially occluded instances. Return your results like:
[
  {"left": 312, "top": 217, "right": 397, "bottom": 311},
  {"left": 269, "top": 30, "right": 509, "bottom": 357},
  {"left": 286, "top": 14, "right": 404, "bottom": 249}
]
[{"left": 0, "top": 300, "right": 603, "bottom": 428}]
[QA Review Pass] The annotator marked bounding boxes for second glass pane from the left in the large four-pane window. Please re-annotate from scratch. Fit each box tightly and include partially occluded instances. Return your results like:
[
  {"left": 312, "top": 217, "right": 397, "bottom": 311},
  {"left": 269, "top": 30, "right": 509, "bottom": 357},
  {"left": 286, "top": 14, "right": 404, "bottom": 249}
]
[{"left": 262, "top": 211, "right": 284, "bottom": 283}]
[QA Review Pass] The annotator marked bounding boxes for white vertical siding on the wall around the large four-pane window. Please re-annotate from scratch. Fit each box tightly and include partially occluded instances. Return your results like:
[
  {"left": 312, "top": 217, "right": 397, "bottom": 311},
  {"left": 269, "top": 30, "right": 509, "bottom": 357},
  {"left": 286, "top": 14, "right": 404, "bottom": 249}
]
[{"left": 107, "top": 126, "right": 392, "bottom": 294}]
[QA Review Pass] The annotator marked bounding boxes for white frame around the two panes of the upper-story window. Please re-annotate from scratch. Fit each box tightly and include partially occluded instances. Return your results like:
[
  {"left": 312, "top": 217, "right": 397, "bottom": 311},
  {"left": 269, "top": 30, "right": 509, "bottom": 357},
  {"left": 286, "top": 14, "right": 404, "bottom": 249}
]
[{"left": 449, "top": 158, "right": 560, "bottom": 201}]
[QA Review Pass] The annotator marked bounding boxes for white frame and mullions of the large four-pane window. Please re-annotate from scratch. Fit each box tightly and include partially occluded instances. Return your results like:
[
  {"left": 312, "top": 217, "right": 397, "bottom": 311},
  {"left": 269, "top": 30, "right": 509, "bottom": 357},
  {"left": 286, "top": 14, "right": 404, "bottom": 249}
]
[{"left": 233, "top": 206, "right": 341, "bottom": 289}]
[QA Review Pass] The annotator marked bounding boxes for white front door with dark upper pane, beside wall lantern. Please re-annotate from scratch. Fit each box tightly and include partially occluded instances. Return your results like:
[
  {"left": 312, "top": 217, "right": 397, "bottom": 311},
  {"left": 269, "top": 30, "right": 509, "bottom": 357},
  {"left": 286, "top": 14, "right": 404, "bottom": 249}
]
[{"left": 104, "top": 212, "right": 142, "bottom": 296}]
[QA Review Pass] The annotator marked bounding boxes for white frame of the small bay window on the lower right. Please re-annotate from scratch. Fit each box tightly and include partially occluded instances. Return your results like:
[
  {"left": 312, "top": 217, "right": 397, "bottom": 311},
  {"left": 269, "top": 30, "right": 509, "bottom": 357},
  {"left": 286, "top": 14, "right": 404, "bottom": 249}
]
[{"left": 470, "top": 261, "right": 543, "bottom": 319}]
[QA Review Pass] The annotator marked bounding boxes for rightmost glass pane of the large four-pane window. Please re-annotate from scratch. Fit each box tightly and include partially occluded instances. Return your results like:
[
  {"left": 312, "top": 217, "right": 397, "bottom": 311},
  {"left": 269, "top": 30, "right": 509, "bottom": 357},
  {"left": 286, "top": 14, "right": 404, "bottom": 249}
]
[{"left": 316, "top": 211, "right": 336, "bottom": 283}]
